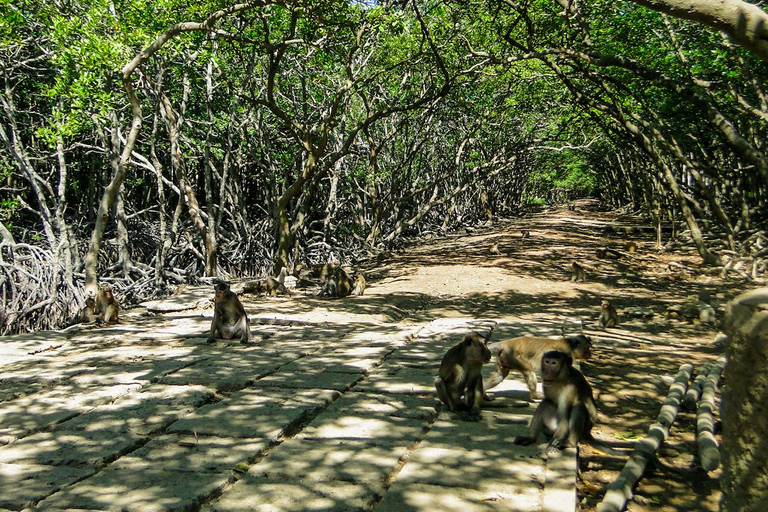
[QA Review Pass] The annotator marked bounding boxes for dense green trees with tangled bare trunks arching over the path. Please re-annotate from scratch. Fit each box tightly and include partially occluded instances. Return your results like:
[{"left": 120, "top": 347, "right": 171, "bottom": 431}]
[{"left": 0, "top": 0, "right": 768, "bottom": 332}]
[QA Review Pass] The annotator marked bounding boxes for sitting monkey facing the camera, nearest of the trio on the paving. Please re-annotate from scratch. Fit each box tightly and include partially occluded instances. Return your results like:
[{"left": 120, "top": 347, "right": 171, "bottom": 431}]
[{"left": 515, "top": 350, "right": 597, "bottom": 450}]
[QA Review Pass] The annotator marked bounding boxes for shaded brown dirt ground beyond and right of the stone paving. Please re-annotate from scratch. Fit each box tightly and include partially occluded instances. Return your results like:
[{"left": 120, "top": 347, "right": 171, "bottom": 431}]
[{"left": 356, "top": 201, "right": 728, "bottom": 512}]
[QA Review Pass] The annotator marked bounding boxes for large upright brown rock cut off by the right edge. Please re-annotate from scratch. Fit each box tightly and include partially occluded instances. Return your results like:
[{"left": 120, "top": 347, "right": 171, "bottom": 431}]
[{"left": 720, "top": 288, "right": 768, "bottom": 512}]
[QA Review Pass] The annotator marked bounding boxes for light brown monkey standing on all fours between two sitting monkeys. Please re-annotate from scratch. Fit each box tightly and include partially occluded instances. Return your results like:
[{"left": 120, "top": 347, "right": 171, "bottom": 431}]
[{"left": 483, "top": 334, "right": 592, "bottom": 400}]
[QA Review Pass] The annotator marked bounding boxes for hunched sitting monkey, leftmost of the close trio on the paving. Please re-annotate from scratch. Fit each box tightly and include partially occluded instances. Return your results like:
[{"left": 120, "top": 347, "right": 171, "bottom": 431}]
[{"left": 435, "top": 332, "right": 491, "bottom": 421}]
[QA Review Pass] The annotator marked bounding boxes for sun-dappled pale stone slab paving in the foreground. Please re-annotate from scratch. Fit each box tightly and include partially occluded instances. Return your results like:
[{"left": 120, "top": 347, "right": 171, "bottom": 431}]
[{"left": 0, "top": 287, "right": 576, "bottom": 512}]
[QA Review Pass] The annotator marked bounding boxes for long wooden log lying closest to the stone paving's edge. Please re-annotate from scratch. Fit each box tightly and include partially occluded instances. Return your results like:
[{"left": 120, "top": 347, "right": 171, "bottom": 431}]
[{"left": 597, "top": 363, "right": 693, "bottom": 512}]
